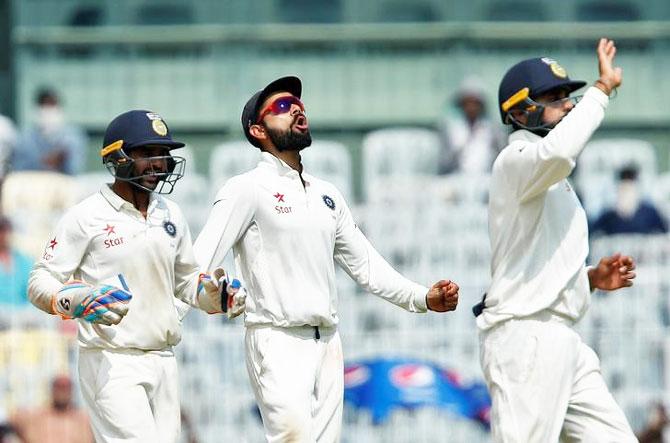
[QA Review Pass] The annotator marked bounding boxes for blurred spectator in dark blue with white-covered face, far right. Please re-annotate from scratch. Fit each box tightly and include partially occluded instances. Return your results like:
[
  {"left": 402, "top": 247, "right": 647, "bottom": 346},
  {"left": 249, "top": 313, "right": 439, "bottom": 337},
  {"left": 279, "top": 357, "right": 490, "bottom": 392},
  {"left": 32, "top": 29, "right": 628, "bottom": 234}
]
[{"left": 591, "top": 165, "right": 668, "bottom": 235}]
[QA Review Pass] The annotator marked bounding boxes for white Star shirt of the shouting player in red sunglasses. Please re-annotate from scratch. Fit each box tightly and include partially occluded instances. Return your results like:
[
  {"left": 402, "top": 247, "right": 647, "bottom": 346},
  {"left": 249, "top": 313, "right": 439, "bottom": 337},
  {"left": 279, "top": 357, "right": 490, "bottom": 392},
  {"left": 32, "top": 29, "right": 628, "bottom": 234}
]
[{"left": 194, "top": 152, "right": 428, "bottom": 327}]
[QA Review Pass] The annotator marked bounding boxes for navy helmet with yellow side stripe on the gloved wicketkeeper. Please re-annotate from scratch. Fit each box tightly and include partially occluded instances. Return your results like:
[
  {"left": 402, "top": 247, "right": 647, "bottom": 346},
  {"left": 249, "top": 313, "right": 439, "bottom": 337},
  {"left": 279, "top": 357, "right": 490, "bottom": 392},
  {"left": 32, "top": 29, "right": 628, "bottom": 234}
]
[{"left": 102, "top": 109, "right": 184, "bottom": 157}]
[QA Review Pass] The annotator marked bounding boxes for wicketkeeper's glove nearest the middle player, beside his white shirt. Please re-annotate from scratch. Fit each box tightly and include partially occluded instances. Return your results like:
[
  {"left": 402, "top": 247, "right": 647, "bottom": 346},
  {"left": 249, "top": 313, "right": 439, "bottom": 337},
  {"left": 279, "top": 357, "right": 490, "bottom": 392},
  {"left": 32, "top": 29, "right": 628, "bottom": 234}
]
[{"left": 198, "top": 268, "right": 246, "bottom": 318}]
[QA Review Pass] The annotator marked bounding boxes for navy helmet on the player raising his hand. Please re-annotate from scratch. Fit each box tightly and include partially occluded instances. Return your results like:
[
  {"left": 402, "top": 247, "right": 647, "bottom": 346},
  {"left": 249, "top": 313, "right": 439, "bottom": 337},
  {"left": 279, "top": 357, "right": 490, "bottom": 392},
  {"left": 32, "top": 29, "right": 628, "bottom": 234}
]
[{"left": 498, "top": 57, "right": 586, "bottom": 123}]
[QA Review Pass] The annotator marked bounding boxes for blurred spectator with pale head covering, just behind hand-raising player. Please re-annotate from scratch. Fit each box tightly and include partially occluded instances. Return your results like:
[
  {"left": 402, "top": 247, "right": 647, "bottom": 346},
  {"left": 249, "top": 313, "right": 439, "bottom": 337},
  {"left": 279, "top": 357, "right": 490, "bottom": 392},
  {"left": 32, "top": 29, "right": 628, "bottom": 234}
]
[{"left": 438, "top": 78, "right": 505, "bottom": 174}]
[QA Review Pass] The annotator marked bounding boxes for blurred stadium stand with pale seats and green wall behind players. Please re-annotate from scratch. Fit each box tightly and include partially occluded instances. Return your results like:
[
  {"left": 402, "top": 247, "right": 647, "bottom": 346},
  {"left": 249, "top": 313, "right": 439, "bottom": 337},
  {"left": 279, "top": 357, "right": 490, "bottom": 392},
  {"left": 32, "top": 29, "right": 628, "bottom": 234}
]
[{"left": 0, "top": 0, "right": 670, "bottom": 443}]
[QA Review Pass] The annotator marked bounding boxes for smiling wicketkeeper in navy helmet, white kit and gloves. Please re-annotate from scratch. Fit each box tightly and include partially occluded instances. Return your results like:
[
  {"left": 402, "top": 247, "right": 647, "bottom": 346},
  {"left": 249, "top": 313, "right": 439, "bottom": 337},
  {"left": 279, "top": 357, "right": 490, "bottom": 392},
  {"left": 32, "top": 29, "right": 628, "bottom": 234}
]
[{"left": 29, "top": 110, "right": 239, "bottom": 443}]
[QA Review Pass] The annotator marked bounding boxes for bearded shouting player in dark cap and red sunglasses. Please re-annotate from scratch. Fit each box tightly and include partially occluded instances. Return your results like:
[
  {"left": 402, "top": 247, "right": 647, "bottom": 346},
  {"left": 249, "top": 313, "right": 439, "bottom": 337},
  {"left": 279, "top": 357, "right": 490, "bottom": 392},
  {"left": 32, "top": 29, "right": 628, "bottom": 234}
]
[{"left": 195, "top": 77, "right": 458, "bottom": 443}]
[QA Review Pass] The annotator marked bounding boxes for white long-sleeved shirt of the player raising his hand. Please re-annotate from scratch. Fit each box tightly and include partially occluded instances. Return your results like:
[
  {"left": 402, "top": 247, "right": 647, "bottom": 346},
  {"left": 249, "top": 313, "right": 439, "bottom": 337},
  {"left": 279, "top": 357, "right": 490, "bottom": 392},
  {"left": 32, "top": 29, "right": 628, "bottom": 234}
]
[{"left": 477, "top": 87, "right": 608, "bottom": 329}]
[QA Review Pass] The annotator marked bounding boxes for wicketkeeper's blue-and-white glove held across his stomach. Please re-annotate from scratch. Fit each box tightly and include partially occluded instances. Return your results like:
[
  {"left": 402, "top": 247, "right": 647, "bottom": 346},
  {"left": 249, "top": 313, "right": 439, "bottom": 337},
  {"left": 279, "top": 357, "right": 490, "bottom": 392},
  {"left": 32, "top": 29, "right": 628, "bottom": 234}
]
[{"left": 51, "top": 281, "right": 133, "bottom": 326}]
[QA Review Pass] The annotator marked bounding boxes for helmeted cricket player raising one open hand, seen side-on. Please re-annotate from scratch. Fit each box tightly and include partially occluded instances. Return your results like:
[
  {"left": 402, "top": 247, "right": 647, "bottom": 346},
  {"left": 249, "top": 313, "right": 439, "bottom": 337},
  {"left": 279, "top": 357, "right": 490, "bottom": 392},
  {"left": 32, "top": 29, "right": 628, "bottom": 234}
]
[{"left": 475, "top": 39, "right": 637, "bottom": 443}]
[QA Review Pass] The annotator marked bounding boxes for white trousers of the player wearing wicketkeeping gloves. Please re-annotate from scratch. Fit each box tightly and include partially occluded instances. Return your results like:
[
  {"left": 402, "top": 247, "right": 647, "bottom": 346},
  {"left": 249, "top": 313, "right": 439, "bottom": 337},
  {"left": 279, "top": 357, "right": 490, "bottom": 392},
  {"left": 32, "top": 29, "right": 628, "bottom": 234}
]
[{"left": 79, "top": 349, "right": 181, "bottom": 443}]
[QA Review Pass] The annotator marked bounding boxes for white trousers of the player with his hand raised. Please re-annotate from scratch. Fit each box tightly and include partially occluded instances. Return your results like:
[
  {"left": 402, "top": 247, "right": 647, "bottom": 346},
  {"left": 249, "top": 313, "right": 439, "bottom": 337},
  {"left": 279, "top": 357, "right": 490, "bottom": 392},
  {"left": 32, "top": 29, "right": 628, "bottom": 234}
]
[{"left": 480, "top": 312, "right": 637, "bottom": 443}]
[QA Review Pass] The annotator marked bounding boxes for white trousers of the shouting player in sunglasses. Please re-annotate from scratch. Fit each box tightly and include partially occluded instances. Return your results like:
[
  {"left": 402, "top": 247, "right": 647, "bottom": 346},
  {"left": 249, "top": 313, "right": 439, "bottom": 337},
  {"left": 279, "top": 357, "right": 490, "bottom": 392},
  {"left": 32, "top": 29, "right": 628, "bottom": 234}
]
[{"left": 245, "top": 326, "right": 344, "bottom": 443}]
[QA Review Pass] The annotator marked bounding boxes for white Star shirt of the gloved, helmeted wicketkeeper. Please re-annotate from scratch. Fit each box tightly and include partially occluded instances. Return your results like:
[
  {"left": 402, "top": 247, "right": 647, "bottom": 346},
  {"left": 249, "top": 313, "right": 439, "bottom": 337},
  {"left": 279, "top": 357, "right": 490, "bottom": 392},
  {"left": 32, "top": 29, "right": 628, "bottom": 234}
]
[{"left": 28, "top": 185, "right": 198, "bottom": 351}]
